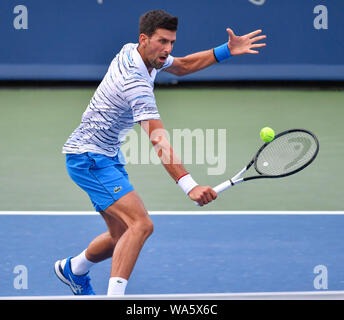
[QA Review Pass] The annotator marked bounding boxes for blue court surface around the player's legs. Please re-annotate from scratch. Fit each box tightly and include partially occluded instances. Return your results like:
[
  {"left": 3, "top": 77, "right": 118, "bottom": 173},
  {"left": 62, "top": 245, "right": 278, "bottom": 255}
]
[{"left": 0, "top": 212, "right": 344, "bottom": 296}]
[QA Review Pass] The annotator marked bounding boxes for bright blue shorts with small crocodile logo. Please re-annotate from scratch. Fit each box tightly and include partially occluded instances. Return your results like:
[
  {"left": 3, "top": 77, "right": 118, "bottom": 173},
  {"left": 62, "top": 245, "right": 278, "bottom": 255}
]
[{"left": 66, "top": 152, "right": 134, "bottom": 211}]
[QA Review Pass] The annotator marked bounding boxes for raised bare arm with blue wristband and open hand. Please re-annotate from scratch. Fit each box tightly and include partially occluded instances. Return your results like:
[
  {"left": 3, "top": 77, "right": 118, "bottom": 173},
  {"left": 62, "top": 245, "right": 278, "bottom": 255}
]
[{"left": 165, "top": 28, "right": 266, "bottom": 76}]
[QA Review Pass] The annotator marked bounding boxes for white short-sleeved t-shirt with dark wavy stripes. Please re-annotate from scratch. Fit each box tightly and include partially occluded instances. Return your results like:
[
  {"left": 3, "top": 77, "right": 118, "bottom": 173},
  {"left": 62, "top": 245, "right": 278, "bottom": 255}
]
[{"left": 62, "top": 43, "right": 173, "bottom": 157}]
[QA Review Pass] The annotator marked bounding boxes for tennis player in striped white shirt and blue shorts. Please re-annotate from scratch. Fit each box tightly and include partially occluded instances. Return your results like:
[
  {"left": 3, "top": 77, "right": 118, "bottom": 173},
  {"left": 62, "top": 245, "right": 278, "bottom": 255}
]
[{"left": 55, "top": 10, "right": 266, "bottom": 295}]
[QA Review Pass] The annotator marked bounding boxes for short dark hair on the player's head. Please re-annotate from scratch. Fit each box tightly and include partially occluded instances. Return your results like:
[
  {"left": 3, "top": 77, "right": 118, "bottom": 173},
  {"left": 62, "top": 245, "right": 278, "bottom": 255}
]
[{"left": 139, "top": 10, "right": 178, "bottom": 37}]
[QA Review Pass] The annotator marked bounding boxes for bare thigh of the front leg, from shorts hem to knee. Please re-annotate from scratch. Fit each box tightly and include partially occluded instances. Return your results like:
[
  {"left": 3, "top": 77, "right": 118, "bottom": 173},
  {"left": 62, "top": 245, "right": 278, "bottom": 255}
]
[{"left": 104, "top": 190, "right": 153, "bottom": 232}]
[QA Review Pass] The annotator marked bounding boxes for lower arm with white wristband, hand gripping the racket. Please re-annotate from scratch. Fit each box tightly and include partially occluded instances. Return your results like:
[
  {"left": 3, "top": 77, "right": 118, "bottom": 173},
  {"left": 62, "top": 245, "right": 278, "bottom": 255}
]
[{"left": 140, "top": 120, "right": 217, "bottom": 206}]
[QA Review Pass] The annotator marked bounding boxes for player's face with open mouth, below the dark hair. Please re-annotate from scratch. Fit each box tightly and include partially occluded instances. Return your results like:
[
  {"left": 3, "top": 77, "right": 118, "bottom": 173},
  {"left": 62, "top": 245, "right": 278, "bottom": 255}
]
[{"left": 140, "top": 29, "right": 176, "bottom": 69}]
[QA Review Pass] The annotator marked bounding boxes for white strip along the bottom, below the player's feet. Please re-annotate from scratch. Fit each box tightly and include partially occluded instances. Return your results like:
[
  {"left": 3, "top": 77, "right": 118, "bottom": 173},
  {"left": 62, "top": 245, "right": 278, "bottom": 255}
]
[{"left": 0, "top": 291, "right": 344, "bottom": 300}]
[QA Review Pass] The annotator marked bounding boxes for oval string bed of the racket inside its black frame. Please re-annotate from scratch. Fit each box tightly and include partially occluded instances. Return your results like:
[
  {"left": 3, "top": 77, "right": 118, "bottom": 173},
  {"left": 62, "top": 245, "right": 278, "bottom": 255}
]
[{"left": 255, "top": 131, "right": 318, "bottom": 176}]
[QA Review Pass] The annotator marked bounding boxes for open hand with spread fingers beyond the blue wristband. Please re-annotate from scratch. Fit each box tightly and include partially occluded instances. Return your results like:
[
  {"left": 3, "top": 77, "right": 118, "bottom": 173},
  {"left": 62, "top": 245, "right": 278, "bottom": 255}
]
[{"left": 226, "top": 28, "right": 266, "bottom": 56}]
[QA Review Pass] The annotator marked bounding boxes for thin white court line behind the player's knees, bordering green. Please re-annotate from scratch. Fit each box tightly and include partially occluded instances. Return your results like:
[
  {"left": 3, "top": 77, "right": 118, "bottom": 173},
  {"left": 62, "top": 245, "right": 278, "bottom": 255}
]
[{"left": 0, "top": 211, "right": 344, "bottom": 216}]
